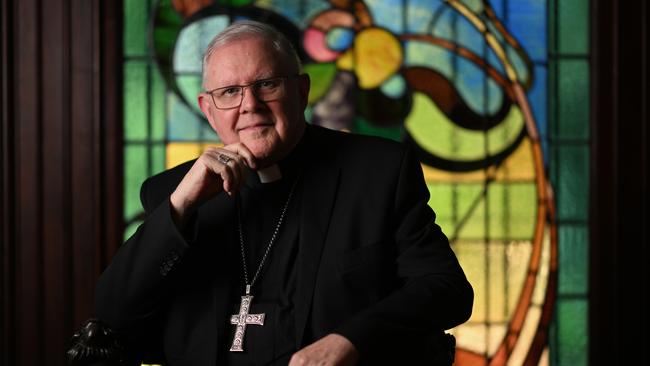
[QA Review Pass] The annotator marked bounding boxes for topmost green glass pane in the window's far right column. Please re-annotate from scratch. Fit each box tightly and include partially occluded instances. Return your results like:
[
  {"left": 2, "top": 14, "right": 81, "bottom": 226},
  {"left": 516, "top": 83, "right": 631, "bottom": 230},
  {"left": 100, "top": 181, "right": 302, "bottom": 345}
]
[{"left": 556, "top": 0, "right": 589, "bottom": 55}]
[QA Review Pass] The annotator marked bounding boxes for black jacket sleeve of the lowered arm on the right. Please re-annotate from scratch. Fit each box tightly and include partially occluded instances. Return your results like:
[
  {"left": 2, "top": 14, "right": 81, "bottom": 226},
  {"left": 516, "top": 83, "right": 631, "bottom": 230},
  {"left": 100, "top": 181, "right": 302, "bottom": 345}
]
[{"left": 335, "top": 147, "right": 473, "bottom": 358}]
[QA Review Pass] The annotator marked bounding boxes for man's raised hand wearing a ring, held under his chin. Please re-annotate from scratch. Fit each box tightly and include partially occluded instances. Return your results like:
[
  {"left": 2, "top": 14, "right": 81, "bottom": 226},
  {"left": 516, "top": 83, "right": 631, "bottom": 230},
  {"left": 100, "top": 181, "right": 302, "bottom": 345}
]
[{"left": 170, "top": 143, "right": 256, "bottom": 227}]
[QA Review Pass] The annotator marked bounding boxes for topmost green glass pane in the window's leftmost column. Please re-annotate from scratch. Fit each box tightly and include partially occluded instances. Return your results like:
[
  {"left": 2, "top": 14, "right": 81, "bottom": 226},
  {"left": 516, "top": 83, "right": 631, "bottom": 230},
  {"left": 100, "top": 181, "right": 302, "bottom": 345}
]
[{"left": 124, "top": 0, "right": 150, "bottom": 56}]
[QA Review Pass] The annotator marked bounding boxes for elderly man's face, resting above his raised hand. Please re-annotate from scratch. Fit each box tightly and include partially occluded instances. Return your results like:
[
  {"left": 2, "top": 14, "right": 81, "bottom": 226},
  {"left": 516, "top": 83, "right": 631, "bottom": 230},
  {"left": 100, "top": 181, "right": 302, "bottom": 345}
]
[{"left": 199, "top": 36, "right": 309, "bottom": 167}]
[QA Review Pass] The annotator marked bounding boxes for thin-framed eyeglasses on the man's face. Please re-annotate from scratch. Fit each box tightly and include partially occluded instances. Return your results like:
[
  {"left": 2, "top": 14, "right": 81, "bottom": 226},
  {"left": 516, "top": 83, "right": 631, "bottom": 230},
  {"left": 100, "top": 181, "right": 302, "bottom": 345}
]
[{"left": 206, "top": 75, "right": 298, "bottom": 109}]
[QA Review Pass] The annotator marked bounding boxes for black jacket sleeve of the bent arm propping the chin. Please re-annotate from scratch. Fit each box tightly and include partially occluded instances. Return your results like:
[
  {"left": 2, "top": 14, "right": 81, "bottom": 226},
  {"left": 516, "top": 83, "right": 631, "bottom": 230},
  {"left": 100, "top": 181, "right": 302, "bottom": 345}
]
[{"left": 95, "top": 177, "right": 190, "bottom": 357}]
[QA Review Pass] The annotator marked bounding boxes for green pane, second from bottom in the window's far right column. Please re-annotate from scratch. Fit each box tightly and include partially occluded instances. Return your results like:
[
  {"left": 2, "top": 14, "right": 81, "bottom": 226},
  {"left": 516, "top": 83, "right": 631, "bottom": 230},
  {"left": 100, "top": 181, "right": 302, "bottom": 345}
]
[{"left": 558, "top": 224, "right": 588, "bottom": 295}]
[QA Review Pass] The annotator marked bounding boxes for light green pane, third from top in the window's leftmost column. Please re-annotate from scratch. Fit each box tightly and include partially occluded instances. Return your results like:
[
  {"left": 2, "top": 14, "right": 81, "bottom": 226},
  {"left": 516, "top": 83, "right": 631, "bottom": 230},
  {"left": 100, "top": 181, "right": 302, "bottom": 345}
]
[{"left": 124, "top": 145, "right": 149, "bottom": 221}]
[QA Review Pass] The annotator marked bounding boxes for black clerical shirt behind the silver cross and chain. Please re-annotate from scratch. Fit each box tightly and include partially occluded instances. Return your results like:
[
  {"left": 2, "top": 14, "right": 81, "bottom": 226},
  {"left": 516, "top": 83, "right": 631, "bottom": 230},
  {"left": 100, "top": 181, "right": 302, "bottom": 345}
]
[{"left": 219, "top": 149, "right": 301, "bottom": 366}]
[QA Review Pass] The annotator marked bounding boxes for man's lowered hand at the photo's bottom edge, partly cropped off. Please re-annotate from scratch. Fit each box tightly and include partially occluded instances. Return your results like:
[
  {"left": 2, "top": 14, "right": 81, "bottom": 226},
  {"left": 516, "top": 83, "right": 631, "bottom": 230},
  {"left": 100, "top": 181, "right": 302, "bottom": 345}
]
[{"left": 289, "top": 333, "right": 359, "bottom": 366}]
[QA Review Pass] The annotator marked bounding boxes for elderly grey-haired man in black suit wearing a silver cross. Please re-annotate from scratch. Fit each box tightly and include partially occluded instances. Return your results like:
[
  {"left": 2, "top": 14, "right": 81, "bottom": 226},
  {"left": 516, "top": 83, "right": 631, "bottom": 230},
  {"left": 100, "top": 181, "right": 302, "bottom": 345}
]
[{"left": 96, "top": 21, "right": 473, "bottom": 365}]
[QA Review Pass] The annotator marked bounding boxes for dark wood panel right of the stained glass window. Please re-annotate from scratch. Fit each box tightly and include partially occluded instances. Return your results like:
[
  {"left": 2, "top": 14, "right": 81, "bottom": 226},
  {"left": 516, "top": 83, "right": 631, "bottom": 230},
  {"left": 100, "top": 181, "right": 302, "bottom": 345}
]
[{"left": 589, "top": 0, "right": 650, "bottom": 365}]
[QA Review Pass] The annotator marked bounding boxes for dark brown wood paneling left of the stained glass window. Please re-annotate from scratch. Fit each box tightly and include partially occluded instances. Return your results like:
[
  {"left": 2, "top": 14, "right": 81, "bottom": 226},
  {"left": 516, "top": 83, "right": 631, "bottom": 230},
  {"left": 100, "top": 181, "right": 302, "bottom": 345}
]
[{"left": 0, "top": 0, "right": 122, "bottom": 365}]
